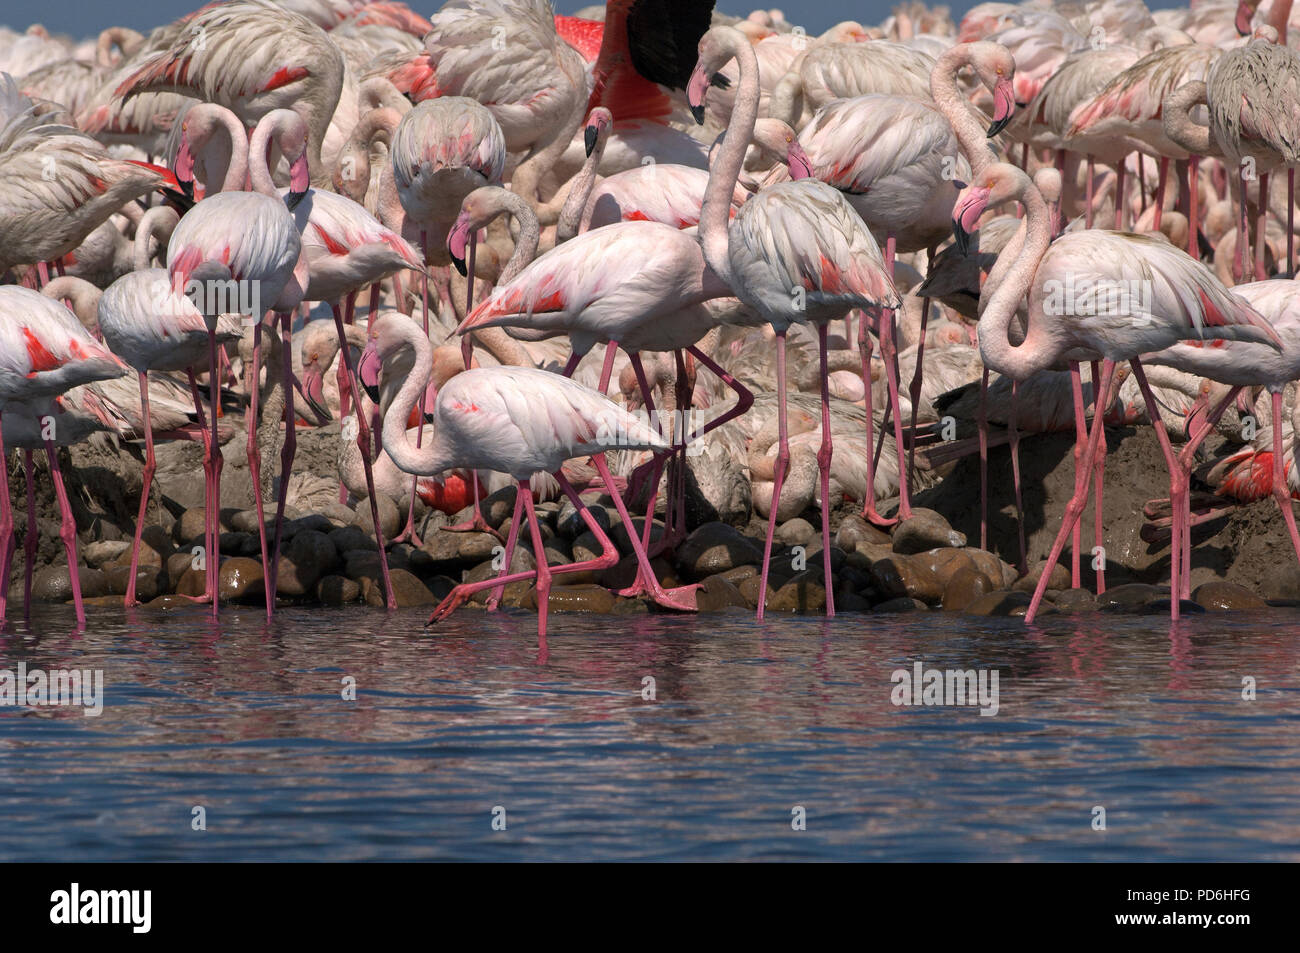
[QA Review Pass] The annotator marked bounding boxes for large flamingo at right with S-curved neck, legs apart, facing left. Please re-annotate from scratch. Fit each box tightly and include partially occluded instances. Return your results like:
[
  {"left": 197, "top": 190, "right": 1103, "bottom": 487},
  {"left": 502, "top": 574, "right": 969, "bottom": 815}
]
[{"left": 953, "top": 163, "right": 1281, "bottom": 621}]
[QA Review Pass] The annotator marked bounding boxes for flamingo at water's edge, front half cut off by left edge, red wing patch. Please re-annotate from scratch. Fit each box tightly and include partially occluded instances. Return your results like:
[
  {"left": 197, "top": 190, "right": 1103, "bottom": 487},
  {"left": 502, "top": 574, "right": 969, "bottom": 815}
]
[{"left": 0, "top": 286, "right": 126, "bottom": 625}]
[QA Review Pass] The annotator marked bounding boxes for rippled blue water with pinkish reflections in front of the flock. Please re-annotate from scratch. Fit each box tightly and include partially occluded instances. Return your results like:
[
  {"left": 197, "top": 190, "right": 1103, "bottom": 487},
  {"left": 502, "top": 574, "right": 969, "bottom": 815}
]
[{"left": 0, "top": 607, "right": 1300, "bottom": 859}]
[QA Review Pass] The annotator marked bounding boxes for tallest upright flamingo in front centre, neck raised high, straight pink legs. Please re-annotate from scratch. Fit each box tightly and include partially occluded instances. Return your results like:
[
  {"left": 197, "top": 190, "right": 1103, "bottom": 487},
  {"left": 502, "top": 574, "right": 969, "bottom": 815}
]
[{"left": 686, "top": 27, "right": 907, "bottom": 619}]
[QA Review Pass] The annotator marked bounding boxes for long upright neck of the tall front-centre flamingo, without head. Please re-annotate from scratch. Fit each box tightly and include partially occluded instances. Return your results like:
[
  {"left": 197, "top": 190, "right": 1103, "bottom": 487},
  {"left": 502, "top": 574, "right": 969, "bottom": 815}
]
[{"left": 699, "top": 31, "right": 759, "bottom": 287}]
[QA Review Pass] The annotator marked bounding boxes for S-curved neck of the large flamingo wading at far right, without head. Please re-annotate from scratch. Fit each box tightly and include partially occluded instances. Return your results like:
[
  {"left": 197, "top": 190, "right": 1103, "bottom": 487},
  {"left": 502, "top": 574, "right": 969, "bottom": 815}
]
[{"left": 979, "top": 179, "right": 1057, "bottom": 381}]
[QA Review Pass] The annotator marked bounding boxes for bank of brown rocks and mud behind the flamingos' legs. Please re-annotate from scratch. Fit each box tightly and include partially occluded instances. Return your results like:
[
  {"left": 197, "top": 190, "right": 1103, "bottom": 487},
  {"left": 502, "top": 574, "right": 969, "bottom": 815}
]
[{"left": 9, "top": 424, "right": 1300, "bottom": 615}]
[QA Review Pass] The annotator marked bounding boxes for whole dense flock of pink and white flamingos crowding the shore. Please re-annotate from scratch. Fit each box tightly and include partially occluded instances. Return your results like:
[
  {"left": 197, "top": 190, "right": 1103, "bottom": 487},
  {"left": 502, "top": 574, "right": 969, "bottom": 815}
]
[{"left": 0, "top": 0, "right": 1300, "bottom": 633}]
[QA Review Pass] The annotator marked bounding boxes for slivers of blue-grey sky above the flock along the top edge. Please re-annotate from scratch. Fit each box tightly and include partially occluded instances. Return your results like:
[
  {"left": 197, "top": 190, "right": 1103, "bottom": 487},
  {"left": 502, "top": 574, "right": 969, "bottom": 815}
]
[{"left": 0, "top": 0, "right": 1179, "bottom": 36}]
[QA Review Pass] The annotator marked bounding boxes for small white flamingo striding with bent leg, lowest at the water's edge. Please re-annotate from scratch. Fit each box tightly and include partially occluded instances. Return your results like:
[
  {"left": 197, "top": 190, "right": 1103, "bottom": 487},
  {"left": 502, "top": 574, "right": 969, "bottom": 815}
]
[{"left": 361, "top": 319, "right": 693, "bottom": 645}]
